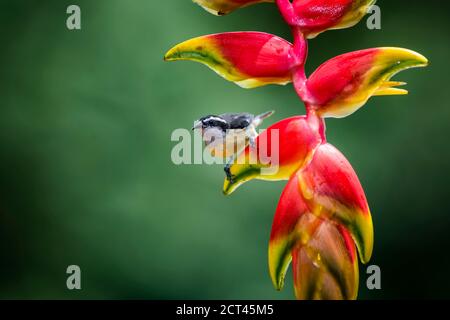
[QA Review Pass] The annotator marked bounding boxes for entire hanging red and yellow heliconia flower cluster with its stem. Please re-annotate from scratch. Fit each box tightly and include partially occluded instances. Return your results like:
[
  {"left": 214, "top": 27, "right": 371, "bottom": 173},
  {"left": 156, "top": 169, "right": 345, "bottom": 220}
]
[{"left": 165, "top": 0, "right": 428, "bottom": 299}]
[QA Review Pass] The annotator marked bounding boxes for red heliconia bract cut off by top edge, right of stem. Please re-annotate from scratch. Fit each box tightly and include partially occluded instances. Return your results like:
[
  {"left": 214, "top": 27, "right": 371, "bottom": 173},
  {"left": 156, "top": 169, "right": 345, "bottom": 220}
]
[{"left": 276, "top": 0, "right": 376, "bottom": 39}]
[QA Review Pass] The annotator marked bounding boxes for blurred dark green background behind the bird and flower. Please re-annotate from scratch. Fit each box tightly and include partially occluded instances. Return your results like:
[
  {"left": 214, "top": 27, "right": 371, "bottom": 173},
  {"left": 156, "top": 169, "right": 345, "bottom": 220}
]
[{"left": 0, "top": 0, "right": 450, "bottom": 299}]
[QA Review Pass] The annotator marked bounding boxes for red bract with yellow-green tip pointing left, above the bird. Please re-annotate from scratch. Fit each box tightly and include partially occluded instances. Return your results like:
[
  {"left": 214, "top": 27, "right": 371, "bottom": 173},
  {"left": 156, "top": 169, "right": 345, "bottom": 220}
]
[{"left": 164, "top": 32, "right": 295, "bottom": 88}]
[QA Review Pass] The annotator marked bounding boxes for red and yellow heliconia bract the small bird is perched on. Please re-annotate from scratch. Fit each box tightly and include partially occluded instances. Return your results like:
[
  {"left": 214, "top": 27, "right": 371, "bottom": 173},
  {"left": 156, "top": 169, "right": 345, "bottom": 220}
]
[{"left": 223, "top": 116, "right": 322, "bottom": 195}]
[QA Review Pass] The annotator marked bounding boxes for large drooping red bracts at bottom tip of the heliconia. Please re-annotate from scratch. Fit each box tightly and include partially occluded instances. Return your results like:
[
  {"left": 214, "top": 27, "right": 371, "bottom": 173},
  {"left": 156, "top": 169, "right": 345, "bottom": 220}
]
[{"left": 269, "top": 143, "right": 373, "bottom": 299}]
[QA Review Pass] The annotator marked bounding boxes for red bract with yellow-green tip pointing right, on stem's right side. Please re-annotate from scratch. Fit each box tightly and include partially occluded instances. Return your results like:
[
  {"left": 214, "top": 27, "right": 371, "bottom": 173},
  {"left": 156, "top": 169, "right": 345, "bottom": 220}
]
[{"left": 306, "top": 48, "right": 428, "bottom": 118}]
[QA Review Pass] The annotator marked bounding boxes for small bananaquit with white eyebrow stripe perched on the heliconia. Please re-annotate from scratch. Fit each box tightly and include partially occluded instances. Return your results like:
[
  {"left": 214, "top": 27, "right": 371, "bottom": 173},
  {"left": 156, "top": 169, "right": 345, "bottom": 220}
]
[{"left": 192, "top": 111, "right": 274, "bottom": 163}]
